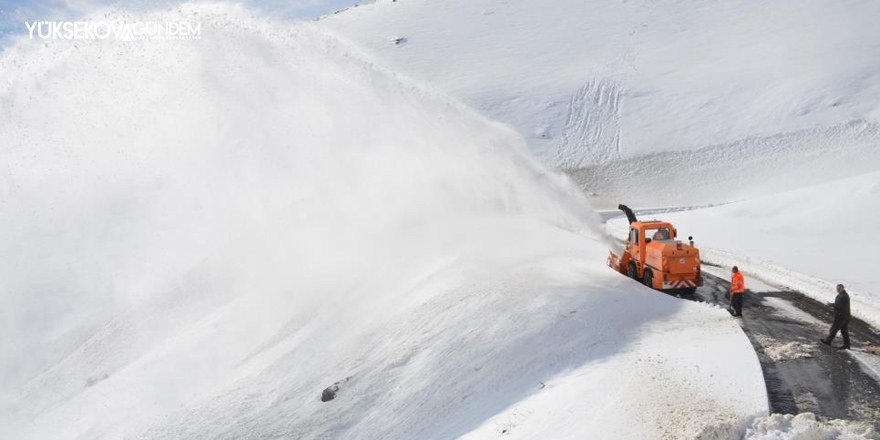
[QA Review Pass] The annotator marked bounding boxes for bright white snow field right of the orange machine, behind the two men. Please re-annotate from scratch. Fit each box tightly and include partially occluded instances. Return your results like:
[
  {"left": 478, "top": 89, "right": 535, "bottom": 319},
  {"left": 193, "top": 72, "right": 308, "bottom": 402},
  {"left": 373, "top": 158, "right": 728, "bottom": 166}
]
[{"left": 612, "top": 172, "right": 880, "bottom": 326}]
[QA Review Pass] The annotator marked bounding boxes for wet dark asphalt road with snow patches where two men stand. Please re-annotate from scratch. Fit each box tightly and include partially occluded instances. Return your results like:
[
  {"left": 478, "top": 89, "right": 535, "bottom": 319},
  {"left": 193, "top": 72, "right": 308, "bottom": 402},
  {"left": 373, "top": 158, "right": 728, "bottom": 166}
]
[{"left": 685, "top": 263, "right": 880, "bottom": 430}]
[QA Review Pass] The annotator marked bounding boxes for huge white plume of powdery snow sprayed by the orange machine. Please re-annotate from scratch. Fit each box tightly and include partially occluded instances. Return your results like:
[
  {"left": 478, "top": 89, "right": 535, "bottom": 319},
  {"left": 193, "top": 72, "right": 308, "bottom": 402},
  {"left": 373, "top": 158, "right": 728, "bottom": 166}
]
[{"left": 0, "top": 6, "right": 612, "bottom": 438}]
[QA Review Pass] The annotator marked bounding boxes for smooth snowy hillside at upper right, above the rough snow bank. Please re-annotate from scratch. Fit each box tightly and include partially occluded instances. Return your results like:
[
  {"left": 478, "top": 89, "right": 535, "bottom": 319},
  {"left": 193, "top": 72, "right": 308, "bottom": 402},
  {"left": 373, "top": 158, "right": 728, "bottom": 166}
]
[{"left": 322, "top": 0, "right": 880, "bottom": 168}]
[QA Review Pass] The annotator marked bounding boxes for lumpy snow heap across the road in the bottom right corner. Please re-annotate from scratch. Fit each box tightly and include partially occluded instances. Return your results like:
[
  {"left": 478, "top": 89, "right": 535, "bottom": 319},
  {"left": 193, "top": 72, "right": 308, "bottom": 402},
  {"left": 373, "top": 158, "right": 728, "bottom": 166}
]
[{"left": 745, "top": 413, "right": 880, "bottom": 440}]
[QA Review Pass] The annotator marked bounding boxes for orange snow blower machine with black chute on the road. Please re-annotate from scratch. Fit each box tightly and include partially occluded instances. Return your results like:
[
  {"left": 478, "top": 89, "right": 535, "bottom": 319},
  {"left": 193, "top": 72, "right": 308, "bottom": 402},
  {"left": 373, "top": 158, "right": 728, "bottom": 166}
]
[{"left": 608, "top": 205, "right": 703, "bottom": 294}]
